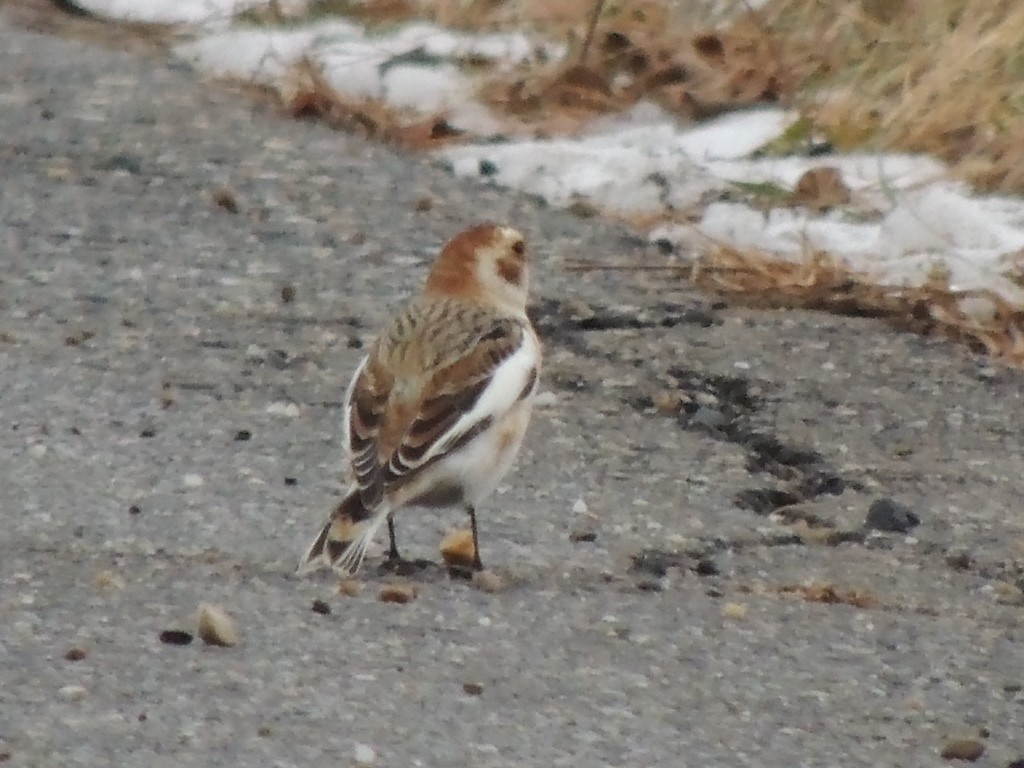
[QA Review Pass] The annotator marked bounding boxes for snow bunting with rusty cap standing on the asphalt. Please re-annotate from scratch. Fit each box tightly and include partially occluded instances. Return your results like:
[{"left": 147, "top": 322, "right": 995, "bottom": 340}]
[{"left": 299, "top": 224, "right": 541, "bottom": 573}]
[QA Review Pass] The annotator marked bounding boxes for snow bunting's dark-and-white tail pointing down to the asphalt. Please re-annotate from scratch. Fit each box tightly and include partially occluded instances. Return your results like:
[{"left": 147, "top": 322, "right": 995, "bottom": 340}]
[{"left": 298, "top": 489, "right": 390, "bottom": 575}]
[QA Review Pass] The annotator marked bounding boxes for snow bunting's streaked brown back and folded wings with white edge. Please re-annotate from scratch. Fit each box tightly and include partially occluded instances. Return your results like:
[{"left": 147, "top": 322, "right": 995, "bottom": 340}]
[{"left": 346, "top": 305, "right": 540, "bottom": 509}]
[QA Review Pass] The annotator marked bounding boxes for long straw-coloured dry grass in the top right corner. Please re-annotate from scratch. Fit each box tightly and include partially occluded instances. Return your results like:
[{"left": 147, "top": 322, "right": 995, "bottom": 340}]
[{"left": 748, "top": 0, "right": 1024, "bottom": 193}]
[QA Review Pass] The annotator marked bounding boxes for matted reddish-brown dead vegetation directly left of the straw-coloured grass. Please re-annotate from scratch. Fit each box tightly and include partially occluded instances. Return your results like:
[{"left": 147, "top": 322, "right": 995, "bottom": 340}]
[{"left": 482, "top": 0, "right": 796, "bottom": 132}]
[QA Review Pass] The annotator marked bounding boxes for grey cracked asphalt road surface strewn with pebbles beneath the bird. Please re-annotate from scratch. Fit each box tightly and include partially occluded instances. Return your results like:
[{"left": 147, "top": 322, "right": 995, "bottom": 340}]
[{"left": 0, "top": 10, "right": 1024, "bottom": 768}]
